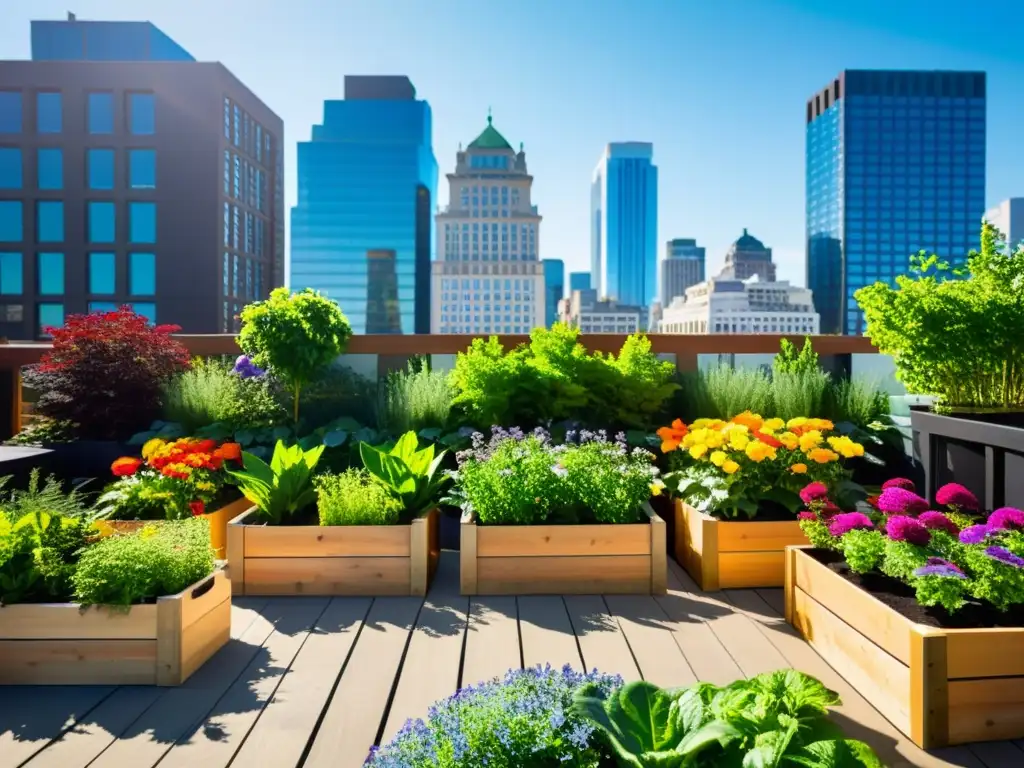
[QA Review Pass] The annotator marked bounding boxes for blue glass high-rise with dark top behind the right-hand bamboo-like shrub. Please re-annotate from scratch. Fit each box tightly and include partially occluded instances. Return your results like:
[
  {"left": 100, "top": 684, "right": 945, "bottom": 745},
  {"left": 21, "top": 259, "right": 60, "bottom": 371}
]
[{"left": 807, "top": 70, "right": 985, "bottom": 334}]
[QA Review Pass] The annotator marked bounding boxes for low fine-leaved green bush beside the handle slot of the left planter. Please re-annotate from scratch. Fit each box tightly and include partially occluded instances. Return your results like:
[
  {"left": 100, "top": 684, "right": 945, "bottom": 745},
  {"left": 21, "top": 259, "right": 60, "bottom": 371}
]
[{"left": 72, "top": 517, "right": 214, "bottom": 605}]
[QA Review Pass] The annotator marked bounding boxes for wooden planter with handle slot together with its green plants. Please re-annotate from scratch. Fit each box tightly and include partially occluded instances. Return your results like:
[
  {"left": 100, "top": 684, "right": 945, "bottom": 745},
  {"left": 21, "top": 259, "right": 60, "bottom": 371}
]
[{"left": 0, "top": 510, "right": 231, "bottom": 685}]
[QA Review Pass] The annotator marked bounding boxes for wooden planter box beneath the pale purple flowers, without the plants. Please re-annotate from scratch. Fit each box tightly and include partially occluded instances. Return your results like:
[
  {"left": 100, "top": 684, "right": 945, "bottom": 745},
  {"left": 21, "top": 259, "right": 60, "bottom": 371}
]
[{"left": 460, "top": 504, "right": 668, "bottom": 595}]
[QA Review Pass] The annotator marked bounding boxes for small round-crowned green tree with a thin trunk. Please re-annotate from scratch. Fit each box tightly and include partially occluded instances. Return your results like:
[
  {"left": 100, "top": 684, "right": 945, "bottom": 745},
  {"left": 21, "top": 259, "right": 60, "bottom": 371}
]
[{"left": 239, "top": 288, "right": 352, "bottom": 424}]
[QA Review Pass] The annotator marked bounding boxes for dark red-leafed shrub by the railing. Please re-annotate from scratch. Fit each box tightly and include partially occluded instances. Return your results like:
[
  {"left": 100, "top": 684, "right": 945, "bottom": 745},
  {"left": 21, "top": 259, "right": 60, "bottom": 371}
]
[{"left": 25, "top": 306, "right": 189, "bottom": 439}]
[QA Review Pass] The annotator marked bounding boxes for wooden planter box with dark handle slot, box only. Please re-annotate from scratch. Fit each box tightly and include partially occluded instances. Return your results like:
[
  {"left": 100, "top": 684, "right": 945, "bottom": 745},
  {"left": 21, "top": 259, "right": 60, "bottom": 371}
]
[{"left": 0, "top": 568, "right": 231, "bottom": 685}]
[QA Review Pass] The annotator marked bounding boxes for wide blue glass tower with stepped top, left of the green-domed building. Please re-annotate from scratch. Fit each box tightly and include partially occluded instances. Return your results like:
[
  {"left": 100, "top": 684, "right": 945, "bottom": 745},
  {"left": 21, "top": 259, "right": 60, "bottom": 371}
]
[{"left": 290, "top": 76, "right": 437, "bottom": 334}]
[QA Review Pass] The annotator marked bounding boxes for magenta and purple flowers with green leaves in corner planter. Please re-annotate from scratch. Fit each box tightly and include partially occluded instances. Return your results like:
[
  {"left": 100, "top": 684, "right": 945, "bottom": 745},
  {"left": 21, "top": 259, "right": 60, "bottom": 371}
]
[{"left": 800, "top": 478, "right": 1024, "bottom": 613}]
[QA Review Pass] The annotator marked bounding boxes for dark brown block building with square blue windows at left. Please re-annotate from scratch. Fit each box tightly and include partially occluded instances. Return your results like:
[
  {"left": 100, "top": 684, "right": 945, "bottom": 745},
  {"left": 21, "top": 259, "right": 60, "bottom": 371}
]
[{"left": 0, "top": 19, "right": 285, "bottom": 339}]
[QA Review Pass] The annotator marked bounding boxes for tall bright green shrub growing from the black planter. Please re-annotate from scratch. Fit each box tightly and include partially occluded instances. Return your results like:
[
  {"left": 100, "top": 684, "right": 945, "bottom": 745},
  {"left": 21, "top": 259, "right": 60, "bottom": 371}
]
[{"left": 855, "top": 222, "right": 1024, "bottom": 409}]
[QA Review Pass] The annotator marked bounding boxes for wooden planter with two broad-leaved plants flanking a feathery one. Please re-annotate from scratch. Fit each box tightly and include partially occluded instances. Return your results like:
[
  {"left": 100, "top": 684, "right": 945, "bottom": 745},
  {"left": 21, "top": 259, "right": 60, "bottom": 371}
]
[{"left": 227, "top": 432, "right": 444, "bottom": 595}]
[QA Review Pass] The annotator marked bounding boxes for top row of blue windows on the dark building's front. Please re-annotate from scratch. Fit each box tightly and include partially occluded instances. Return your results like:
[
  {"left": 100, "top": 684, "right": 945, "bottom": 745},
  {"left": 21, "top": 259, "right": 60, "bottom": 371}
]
[{"left": 0, "top": 90, "right": 157, "bottom": 136}]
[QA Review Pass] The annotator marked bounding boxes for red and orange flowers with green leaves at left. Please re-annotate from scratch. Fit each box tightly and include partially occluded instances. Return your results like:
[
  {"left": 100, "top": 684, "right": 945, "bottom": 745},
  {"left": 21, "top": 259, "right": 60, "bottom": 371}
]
[{"left": 96, "top": 437, "right": 242, "bottom": 520}]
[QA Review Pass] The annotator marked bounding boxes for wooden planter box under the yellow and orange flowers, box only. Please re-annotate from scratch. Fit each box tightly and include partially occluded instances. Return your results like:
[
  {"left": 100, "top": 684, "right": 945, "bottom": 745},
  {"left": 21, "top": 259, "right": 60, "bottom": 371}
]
[{"left": 675, "top": 499, "right": 807, "bottom": 592}]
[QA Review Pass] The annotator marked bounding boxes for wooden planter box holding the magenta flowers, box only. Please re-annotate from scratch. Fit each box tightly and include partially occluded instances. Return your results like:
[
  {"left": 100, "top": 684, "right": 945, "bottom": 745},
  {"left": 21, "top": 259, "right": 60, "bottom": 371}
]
[{"left": 785, "top": 547, "right": 1024, "bottom": 749}]
